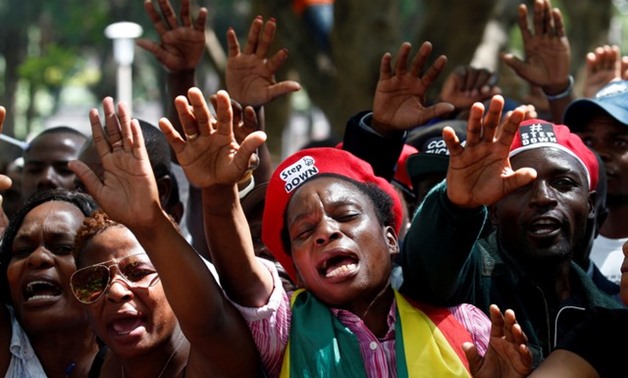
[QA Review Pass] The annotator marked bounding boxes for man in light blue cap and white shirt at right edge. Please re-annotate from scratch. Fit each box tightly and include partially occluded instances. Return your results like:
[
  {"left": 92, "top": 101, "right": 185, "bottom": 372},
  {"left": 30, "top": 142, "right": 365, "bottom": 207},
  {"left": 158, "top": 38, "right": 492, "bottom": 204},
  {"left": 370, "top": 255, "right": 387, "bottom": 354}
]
[{"left": 565, "top": 80, "right": 628, "bottom": 285}]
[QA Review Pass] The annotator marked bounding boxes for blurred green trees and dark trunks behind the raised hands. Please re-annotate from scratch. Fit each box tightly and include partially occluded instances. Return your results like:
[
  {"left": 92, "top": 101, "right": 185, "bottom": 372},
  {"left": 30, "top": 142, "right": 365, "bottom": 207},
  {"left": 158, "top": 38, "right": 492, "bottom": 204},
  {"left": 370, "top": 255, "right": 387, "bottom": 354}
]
[{"left": 0, "top": 0, "right": 614, "bottom": 159}]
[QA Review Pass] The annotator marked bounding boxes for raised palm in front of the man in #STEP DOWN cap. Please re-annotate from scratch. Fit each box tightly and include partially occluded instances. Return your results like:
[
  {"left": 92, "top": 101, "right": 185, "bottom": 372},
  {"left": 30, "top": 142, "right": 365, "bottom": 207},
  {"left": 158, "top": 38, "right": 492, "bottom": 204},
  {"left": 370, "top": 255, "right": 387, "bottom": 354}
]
[{"left": 443, "top": 95, "right": 536, "bottom": 208}]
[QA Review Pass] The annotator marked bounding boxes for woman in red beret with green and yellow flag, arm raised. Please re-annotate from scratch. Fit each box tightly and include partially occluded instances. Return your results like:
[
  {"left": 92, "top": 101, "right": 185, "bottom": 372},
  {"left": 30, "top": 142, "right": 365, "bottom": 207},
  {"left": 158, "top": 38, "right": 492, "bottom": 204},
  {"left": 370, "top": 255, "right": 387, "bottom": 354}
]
[{"left": 155, "top": 88, "right": 523, "bottom": 377}]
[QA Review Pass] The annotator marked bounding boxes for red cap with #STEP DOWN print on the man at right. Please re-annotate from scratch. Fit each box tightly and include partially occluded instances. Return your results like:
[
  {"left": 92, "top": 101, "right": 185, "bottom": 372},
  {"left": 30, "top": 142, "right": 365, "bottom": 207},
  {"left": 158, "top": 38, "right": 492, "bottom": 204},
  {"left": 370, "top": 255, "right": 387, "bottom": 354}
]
[{"left": 509, "top": 119, "right": 599, "bottom": 190}]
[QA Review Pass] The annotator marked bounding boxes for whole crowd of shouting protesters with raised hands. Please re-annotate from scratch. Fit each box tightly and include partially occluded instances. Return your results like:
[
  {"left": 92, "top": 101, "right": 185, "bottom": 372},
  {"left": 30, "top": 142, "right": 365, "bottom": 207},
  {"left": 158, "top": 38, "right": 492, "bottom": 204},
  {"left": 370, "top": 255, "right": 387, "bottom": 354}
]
[{"left": 0, "top": 0, "right": 628, "bottom": 378}]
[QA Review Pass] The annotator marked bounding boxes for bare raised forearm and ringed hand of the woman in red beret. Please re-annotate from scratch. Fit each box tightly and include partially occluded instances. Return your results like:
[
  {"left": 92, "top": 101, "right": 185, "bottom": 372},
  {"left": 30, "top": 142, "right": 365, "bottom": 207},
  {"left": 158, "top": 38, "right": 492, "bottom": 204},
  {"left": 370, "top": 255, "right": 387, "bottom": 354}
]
[{"left": 159, "top": 88, "right": 273, "bottom": 307}]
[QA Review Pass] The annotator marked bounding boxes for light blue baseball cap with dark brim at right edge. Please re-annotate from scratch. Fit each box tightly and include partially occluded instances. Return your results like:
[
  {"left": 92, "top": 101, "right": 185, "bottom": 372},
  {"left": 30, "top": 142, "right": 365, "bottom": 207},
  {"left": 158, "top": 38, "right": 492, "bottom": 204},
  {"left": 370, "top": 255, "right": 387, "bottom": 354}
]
[{"left": 563, "top": 80, "right": 628, "bottom": 132}]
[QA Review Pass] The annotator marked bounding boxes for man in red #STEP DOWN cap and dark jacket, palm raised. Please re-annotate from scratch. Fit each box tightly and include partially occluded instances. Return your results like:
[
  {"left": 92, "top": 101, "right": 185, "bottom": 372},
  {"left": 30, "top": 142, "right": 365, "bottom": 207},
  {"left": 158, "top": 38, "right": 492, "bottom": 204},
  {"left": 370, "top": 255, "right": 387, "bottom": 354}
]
[{"left": 400, "top": 96, "right": 621, "bottom": 366}]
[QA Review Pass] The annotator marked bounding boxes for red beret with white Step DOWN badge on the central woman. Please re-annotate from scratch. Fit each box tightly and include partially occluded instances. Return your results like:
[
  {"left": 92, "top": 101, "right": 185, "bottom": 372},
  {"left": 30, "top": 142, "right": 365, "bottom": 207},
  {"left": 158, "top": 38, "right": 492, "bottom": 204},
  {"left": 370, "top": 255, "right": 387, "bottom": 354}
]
[{"left": 262, "top": 147, "right": 403, "bottom": 282}]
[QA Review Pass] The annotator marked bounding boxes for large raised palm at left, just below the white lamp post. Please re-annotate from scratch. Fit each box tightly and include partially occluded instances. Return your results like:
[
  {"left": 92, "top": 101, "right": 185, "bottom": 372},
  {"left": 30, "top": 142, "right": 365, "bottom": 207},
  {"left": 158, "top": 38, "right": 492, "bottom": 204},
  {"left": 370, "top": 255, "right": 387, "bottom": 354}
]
[{"left": 69, "top": 97, "right": 162, "bottom": 228}]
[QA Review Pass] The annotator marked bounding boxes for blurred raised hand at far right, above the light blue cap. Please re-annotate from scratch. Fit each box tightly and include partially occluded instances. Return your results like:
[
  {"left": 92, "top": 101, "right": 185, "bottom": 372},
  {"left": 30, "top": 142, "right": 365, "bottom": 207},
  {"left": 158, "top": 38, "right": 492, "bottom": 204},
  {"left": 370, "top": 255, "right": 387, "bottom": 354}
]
[{"left": 583, "top": 45, "right": 622, "bottom": 98}]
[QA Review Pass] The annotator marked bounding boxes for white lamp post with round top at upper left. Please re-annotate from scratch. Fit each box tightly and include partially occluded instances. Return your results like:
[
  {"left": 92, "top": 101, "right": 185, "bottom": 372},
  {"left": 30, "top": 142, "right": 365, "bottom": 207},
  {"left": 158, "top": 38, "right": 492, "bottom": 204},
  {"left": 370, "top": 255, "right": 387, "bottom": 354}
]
[{"left": 105, "top": 22, "right": 142, "bottom": 114}]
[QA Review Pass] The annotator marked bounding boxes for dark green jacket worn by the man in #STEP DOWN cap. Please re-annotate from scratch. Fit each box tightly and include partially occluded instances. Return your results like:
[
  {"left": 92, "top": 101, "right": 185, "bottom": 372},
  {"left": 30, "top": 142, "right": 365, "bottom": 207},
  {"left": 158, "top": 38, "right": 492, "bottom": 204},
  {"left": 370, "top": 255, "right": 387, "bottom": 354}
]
[{"left": 400, "top": 182, "right": 622, "bottom": 366}]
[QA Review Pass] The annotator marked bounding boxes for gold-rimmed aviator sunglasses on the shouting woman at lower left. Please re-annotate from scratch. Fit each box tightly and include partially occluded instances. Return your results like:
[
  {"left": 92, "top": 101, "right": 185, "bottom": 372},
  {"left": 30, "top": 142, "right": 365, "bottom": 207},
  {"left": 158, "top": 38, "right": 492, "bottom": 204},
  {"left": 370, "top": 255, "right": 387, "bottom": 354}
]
[{"left": 70, "top": 253, "right": 159, "bottom": 304}]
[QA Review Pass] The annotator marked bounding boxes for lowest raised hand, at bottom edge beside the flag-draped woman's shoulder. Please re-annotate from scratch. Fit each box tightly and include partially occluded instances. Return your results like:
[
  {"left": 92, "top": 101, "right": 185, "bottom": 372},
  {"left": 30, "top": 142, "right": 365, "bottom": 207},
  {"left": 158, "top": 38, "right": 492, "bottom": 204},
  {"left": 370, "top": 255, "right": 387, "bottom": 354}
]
[{"left": 463, "top": 305, "right": 532, "bottom": 378}]
